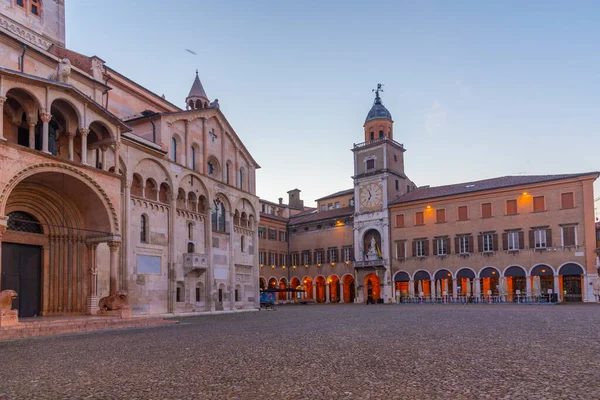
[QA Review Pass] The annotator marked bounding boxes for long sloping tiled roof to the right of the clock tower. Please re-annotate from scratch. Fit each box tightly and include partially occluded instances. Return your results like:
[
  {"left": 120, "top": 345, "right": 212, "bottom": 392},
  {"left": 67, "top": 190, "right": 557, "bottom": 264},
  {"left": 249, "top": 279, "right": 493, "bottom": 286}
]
[{"left": 390, "top": 172, "right": 600, "bottom": 204}]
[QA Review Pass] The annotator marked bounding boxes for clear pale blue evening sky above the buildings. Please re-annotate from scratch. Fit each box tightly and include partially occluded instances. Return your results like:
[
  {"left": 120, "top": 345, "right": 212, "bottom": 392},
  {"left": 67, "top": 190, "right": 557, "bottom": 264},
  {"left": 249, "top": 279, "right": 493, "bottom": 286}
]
[{"left": 66, "top": 0, "right": 600, "bottom": 214}]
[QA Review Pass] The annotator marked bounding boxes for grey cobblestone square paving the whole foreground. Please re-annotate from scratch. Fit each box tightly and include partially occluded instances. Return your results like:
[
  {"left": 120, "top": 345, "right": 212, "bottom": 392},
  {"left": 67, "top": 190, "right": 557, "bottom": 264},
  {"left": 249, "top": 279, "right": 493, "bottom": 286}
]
[{"left": 0, "top": 305, "right": 600, "bottom": 399}]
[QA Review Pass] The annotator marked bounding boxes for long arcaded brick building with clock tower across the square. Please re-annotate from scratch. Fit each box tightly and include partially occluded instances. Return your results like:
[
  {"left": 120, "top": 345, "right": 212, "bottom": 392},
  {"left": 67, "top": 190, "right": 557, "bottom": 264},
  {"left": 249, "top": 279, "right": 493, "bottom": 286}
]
[{"left": 259, "top": 90, "right": 600, "bottom": 302}]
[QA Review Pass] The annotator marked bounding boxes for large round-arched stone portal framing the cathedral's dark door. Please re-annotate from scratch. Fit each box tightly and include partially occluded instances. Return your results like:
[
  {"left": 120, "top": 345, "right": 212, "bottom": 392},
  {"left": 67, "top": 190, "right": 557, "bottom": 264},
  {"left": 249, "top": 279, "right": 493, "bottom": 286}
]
[{"left": 0, "top": 168, "right": 120, "bottom": 316}]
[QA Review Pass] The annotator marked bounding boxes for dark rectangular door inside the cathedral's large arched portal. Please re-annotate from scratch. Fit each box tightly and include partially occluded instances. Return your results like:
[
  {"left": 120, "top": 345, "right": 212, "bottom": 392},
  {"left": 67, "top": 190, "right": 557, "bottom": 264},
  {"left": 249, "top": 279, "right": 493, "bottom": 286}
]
[{"left": 2, "top": 243, "right": 42, "bottom": 317}]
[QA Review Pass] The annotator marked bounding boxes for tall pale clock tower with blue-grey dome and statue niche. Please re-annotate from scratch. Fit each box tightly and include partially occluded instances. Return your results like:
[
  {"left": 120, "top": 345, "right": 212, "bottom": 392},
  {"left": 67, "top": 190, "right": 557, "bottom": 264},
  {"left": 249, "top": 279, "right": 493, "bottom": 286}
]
[{"left": 352, "top": 84, "right": 414, "bottom": 303}]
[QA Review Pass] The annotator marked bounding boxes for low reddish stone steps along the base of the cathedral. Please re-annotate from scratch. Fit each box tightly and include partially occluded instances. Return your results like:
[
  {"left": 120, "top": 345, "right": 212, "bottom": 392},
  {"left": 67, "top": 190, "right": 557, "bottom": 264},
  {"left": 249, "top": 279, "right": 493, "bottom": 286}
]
[{"left": 0, "top": 317, "right": 178, "bottom": 340}]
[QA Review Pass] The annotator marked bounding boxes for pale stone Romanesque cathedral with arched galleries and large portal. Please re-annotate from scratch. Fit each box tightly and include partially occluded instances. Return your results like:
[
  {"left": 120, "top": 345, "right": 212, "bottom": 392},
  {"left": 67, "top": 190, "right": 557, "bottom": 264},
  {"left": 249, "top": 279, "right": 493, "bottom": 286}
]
[{"left": 0, "top": 0, "right": 259, "bottom": 317}]
